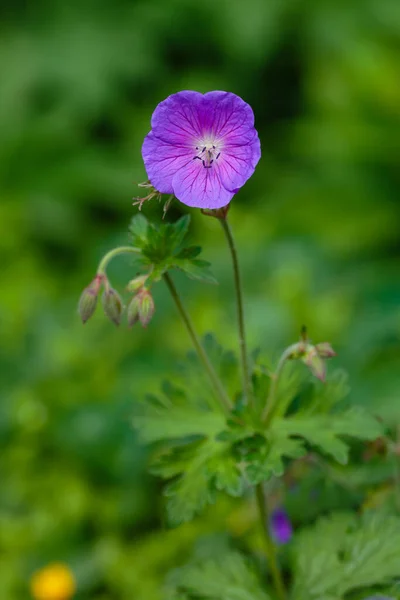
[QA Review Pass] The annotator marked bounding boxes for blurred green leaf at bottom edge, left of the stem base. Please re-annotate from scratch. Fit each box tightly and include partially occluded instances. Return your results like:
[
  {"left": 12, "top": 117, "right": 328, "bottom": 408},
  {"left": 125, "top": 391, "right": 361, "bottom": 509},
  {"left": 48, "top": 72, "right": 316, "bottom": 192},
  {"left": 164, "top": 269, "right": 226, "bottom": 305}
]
[{"left": 169, "top": 551, "right": 270, "bottom": 600}]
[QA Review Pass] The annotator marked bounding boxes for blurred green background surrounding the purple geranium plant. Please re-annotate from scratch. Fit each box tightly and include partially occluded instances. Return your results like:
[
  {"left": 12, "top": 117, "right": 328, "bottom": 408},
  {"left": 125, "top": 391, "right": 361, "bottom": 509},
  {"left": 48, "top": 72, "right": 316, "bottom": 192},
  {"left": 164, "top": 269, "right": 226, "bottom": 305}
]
[{"left": 0, "top": 0, "right": 400, "bottom": 600}]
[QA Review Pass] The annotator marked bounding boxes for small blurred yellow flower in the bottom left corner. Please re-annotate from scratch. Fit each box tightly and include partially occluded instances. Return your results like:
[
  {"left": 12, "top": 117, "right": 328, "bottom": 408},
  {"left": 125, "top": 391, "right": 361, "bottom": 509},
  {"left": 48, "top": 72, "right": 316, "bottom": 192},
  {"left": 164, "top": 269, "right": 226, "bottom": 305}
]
[{"left": 31, "top": 563, "right": 76, "bottom": 600}]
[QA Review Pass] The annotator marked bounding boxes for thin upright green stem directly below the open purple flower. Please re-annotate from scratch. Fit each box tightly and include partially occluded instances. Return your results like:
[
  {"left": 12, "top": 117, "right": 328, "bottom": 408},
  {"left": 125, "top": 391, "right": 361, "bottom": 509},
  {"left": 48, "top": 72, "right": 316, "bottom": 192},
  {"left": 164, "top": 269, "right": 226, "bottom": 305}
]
[{"left": 220, "top": 218, "right": 252, "bottom": 401}]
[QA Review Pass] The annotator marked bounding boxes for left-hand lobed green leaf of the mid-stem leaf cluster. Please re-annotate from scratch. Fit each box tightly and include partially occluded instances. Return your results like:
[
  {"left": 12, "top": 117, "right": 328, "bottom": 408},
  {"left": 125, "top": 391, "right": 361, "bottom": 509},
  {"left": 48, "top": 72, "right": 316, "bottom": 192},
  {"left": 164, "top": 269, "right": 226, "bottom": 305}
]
[{"left": 133, "top": 338, "right": 243, "bottom": 525}]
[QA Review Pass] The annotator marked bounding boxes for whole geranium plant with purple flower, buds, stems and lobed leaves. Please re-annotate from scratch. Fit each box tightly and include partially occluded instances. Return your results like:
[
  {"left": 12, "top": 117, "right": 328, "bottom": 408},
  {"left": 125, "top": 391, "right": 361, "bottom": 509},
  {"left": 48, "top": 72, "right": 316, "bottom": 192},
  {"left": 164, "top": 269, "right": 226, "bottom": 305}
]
[{"left": 79, "top": 91, "right": 400, "bottom": 600}]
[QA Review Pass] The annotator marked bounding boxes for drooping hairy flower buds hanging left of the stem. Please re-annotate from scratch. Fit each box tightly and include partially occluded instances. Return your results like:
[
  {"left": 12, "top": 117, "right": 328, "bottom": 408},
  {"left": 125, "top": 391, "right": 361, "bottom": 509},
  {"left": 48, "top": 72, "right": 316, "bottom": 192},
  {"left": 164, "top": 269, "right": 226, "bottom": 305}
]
[{"left": 78, "top": 273, "right": 155, "bottom": 327}]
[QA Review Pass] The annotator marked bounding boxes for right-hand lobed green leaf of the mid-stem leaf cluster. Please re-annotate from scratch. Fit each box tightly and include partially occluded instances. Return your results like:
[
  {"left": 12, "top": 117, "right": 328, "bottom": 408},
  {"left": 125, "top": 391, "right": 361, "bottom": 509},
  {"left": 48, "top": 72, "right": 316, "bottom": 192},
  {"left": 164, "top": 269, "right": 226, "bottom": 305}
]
[{"left": 222, "top": 366, "right": 384, "bottom": 485}]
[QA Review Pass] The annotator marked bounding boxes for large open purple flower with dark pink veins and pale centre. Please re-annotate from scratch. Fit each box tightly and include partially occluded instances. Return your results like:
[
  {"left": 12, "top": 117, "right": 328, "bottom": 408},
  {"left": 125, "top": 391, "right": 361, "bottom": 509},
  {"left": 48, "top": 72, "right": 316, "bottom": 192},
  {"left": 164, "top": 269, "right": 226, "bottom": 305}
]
[{"left": 142, "top": 91, "right": 261, "bottom": 209}]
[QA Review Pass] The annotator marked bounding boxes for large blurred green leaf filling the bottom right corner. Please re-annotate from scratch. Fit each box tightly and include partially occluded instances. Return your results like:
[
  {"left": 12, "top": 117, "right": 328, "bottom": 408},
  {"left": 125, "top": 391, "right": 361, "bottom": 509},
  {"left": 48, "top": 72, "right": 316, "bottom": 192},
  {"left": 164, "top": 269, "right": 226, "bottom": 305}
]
[{"left": 292, "top": 514, "right": 400, "bottom": 600}]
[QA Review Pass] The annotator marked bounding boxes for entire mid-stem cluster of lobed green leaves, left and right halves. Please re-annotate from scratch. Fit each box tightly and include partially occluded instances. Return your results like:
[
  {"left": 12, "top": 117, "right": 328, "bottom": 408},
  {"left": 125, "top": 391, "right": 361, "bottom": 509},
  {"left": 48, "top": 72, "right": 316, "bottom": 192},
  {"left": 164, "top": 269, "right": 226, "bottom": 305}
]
[{"left": 133, "top": 328, "right": 382, "bottom": 525}]
